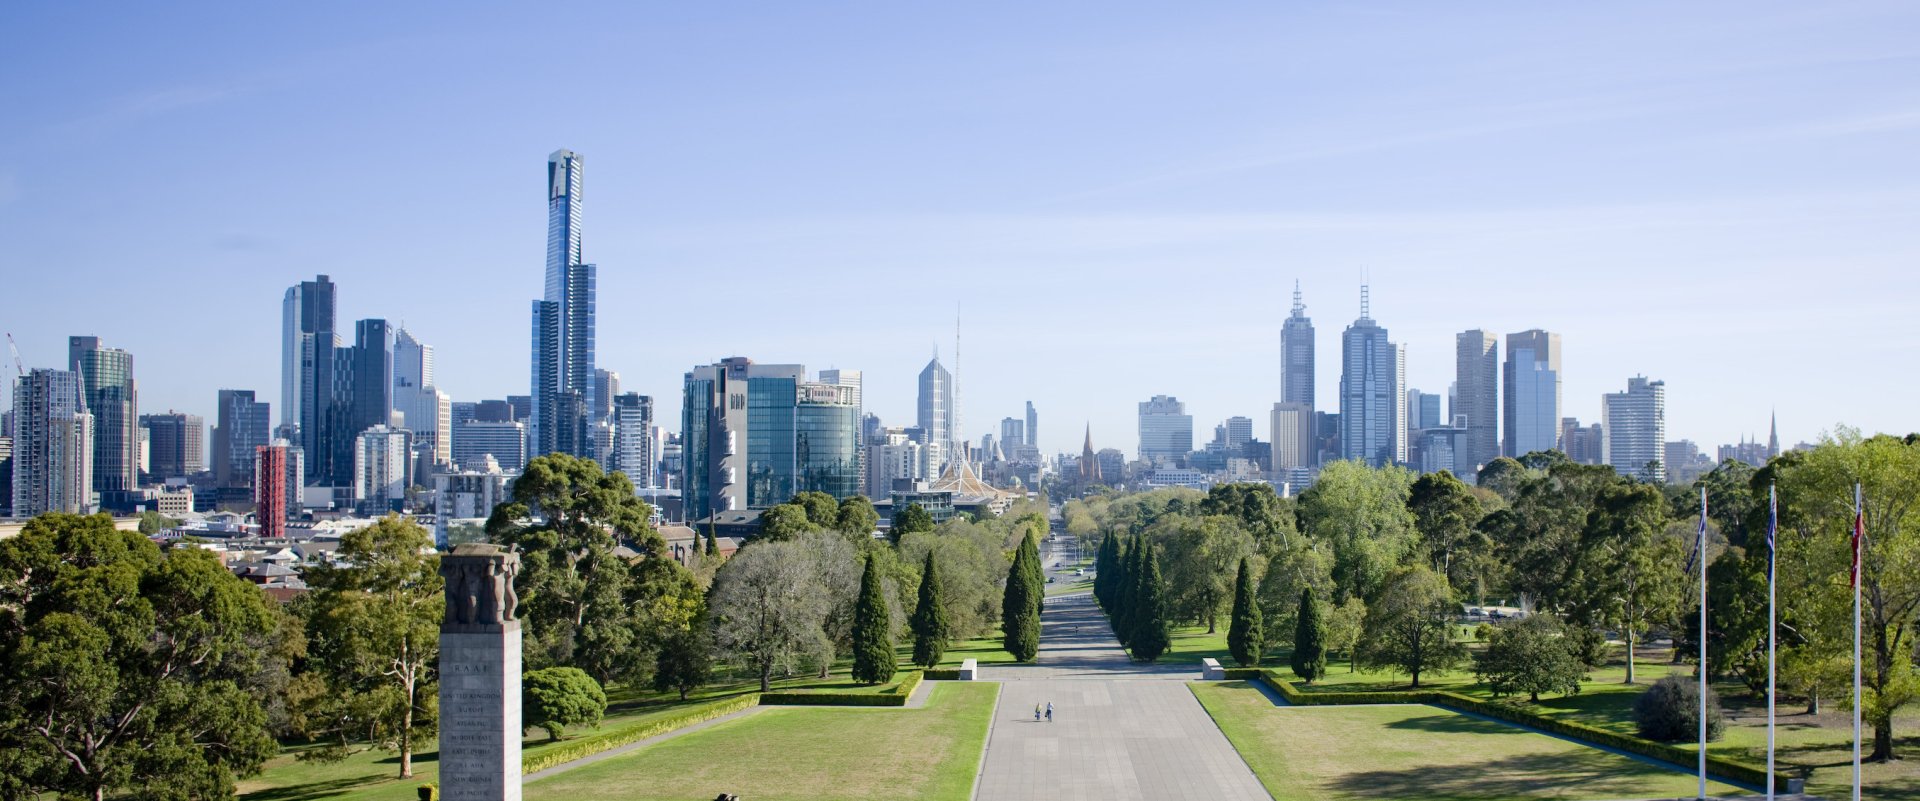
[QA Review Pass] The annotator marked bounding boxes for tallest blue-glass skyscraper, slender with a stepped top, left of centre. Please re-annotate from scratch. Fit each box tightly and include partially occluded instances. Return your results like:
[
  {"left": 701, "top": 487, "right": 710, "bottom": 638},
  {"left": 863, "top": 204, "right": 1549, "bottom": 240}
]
[{"left": 530, "top": 150, "right": 599, "bottom": 457}]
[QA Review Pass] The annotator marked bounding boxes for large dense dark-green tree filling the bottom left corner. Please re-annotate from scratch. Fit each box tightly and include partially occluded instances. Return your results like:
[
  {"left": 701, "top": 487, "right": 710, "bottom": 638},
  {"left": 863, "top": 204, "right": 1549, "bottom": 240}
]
[{"left": 0, "top": 513, "right": 294, "bottom": 801}]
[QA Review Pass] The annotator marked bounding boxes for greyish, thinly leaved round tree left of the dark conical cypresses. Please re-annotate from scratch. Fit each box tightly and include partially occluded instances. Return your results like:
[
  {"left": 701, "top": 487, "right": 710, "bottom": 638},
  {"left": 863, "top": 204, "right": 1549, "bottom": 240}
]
[{"left": 712, "top": 542, "right": 833, "bottom": 692}]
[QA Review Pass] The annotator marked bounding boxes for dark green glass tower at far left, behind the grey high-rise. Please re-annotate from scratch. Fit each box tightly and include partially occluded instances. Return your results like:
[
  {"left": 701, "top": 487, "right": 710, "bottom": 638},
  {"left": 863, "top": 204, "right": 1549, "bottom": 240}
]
[{"left": 67, "top": 336, "right": 140, "bottom": 491}]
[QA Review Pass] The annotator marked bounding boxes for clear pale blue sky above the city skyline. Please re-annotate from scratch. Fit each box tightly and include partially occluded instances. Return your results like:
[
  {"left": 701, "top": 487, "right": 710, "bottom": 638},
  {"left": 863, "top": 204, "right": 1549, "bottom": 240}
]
[{"left": 0, "top": 0, "right": 1920, "bottom": 453}]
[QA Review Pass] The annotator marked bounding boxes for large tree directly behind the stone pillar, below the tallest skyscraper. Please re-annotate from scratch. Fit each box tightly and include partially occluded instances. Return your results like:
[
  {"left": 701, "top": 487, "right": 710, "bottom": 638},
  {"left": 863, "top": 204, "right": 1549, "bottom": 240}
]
[{"left": 488, "top": 453, "right": 666, "bottom": 684}]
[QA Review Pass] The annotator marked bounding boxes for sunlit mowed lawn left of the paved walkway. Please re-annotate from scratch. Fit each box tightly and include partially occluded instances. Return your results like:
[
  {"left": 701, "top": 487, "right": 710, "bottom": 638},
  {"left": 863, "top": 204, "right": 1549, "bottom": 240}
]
[{"left": 524, "top": 682, "right": 1000, "bottom": 801}]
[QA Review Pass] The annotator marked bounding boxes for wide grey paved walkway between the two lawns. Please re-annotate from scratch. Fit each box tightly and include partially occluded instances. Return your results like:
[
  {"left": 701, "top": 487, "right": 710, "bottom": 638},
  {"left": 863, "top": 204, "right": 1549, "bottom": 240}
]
[{"left": 973, "top": 576, "right": 1271, "bottom": 801}]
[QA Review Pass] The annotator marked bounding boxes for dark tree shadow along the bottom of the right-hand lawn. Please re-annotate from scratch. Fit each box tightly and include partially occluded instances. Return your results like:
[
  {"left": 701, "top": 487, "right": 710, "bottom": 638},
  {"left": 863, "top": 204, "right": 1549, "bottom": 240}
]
[{"left": 1331, "top": 745, "right": 1697, "bottom": 801}]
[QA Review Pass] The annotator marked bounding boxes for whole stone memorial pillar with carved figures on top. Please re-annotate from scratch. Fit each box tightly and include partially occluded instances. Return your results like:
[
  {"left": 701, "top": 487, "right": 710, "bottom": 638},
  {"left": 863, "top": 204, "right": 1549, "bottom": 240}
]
[{"left": 440, "top": 544, "right": 520, "bottom": 801}]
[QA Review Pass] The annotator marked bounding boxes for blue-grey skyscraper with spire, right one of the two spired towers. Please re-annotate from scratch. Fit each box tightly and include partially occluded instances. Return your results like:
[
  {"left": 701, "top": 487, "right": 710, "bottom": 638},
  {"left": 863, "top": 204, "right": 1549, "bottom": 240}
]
[{"left": 1340, "top": 284, "right": 1407, "bottom": 467}]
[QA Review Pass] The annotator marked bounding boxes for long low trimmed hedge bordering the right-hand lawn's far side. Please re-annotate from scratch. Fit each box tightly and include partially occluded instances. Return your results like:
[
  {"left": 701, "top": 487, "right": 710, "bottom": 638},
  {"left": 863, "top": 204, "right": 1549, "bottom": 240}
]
[{"left": 1260, "top": 670, "right": 1791, "bottom": 793}]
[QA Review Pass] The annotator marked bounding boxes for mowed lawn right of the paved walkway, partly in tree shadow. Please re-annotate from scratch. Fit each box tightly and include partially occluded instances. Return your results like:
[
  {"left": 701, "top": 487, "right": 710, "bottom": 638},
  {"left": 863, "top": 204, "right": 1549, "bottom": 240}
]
[{"left": 1192, "top": 682, "right": 1747, "bottom": 801}]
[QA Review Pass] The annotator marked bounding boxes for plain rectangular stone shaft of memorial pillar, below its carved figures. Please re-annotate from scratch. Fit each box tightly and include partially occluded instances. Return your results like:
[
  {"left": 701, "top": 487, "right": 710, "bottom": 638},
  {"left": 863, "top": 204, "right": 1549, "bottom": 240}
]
[{"left": 440, "top": 622, "right": 520, "bottom": 801}]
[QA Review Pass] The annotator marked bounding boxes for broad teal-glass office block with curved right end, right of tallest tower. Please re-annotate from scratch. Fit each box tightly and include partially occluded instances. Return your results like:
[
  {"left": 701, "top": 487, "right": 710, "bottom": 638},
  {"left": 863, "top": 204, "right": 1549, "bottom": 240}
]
[{"left": 682, "top": 355, "right": 860, "bottom": 521}]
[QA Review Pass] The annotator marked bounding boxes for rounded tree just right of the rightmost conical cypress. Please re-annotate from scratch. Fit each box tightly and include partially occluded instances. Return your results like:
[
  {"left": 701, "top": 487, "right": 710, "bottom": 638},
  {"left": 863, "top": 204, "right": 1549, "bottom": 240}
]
[{"left": 1357, "top": 565, "right": 1467, "bottom": 688}]
